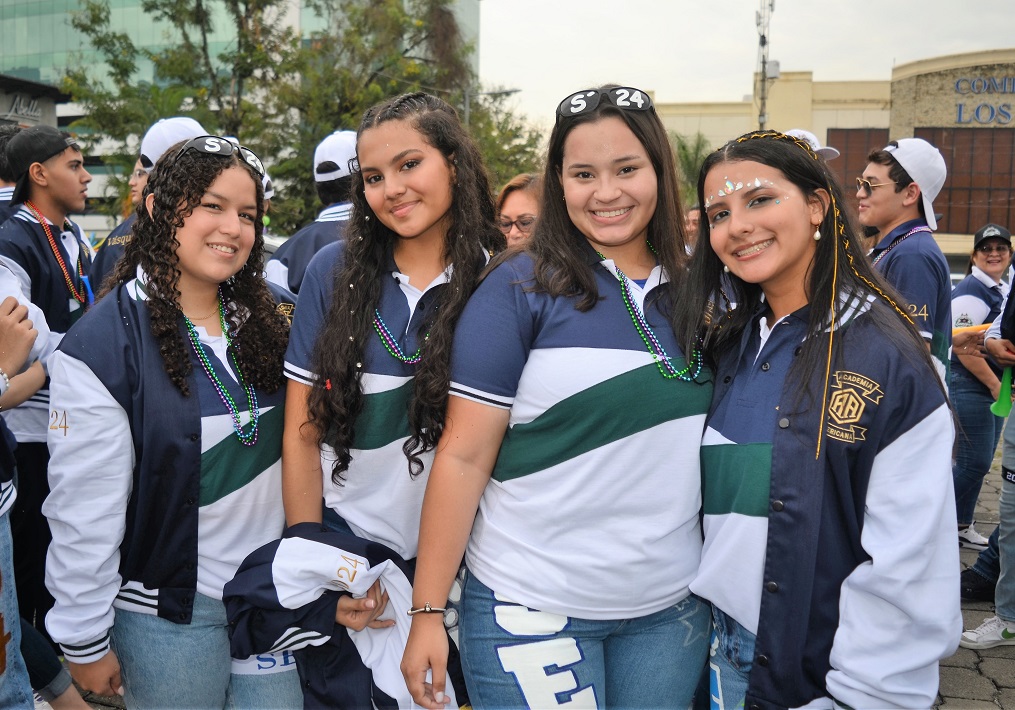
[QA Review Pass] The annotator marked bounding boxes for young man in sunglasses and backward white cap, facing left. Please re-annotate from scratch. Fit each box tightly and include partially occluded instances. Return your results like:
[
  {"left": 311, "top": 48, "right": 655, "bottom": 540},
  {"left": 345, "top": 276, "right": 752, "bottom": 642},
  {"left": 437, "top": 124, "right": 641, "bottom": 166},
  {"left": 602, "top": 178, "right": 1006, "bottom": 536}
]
[{"left": 857, "top": 138, "right": 952, "bottom": 382}]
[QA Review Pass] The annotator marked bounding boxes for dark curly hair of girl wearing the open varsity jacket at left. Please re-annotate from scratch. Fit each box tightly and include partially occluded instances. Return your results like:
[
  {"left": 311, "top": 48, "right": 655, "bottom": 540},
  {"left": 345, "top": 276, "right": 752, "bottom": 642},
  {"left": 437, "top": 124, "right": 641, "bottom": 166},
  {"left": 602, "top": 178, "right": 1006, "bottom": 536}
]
[{"left": 102, "top": 137, "right": 288, "bottom": 396}]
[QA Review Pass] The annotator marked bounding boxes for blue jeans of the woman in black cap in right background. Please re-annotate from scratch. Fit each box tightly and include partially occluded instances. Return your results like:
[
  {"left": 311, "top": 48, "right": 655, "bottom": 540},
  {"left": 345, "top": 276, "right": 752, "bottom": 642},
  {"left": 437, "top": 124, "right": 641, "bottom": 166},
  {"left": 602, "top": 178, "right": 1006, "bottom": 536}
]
[{"left": 948, "top": 369, "right": 1005, "bottom": 527}]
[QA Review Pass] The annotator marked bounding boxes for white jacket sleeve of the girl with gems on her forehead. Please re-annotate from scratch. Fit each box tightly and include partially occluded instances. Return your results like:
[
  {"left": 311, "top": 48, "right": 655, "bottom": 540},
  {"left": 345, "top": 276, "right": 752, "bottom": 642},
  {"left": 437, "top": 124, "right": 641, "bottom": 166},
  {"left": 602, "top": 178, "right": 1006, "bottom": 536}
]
[{"left": 825, "top": 405, "right": 962, "bottom": 710}]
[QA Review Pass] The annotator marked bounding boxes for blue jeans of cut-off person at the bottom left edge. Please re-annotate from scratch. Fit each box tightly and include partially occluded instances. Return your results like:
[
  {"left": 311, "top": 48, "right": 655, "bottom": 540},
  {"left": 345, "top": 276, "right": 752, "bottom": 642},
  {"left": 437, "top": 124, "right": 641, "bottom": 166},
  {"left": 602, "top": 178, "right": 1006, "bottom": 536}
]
[{"left": 0, "top": 513, "right": 36, "bottom": 708}]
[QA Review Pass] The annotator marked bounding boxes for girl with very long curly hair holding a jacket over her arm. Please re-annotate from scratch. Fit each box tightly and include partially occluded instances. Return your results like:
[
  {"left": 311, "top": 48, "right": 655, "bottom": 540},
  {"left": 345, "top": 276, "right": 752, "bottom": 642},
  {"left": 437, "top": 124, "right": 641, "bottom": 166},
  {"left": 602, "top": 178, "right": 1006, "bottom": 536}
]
[{"left": 269, "top": 93, "right": 504, "bottom": 704}]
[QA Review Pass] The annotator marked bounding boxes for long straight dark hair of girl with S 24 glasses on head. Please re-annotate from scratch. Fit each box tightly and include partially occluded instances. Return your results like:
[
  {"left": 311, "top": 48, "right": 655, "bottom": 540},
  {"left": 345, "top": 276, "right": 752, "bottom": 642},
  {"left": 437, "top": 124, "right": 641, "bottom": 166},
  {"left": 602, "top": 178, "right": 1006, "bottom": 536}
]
[{"left": 526, "top": 84, "right": 690, "bottom": 310}]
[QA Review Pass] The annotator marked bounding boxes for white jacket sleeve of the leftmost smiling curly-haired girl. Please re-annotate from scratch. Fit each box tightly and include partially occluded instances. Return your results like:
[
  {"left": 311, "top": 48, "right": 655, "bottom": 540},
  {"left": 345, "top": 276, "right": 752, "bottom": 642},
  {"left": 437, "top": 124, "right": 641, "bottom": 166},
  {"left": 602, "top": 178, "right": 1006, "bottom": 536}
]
[{"left": 43, "top": 352, "right": 134, "bottom": 663}]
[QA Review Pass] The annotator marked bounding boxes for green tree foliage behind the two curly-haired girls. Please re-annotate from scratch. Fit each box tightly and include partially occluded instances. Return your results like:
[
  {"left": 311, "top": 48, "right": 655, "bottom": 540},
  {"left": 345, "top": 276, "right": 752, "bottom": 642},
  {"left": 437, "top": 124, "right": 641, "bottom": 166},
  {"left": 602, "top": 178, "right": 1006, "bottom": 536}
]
[{"left": 64, "top": 0, "right": 540, "bottom": 233}]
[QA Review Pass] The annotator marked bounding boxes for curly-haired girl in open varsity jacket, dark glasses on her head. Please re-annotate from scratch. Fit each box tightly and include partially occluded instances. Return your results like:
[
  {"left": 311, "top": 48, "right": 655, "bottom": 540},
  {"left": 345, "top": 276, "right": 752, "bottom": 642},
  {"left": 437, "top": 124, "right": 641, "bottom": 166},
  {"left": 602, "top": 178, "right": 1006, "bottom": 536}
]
[{"left": 44, "top": 136, "right": 302, "bottom": 708}]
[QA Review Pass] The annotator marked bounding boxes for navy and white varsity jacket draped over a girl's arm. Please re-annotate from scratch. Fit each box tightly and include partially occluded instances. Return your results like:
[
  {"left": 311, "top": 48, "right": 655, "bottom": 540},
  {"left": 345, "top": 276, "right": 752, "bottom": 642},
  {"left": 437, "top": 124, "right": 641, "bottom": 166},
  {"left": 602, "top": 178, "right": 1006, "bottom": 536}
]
[{"left": 223, "top": 522, "right": 467, "bottom": 709}]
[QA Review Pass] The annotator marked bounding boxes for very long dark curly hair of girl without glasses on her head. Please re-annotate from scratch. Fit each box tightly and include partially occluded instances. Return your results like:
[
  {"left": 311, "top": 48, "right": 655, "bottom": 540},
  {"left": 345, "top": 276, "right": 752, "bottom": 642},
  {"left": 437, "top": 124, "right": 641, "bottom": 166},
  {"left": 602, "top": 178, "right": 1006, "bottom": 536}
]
[{"left": 308, "top": 92, "right": 505, "bottom": 485}]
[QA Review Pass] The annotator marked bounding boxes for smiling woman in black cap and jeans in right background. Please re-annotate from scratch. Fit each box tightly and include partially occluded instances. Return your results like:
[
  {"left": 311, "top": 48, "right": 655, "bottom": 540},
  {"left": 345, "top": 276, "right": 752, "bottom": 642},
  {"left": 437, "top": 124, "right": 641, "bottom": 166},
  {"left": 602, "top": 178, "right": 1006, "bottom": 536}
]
[{"left": 948, "top": 224, "right": 1012, "bottom": 550}]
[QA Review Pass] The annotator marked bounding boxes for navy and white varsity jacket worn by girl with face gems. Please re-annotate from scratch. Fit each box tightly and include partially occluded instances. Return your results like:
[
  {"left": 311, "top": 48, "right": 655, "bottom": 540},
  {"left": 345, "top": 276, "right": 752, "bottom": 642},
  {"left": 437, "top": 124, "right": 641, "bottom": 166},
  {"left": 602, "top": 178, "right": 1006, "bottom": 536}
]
[{"left": 706, "top": 301, "right": 962, "bottom": 710}]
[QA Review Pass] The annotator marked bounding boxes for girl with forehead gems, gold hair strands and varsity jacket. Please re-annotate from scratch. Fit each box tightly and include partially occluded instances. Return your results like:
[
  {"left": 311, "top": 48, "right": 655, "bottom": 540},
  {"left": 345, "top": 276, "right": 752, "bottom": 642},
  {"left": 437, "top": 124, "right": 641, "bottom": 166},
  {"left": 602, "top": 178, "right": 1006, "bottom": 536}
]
[{"left": 680, "top": 131, "right": 961, "bottom": 709}]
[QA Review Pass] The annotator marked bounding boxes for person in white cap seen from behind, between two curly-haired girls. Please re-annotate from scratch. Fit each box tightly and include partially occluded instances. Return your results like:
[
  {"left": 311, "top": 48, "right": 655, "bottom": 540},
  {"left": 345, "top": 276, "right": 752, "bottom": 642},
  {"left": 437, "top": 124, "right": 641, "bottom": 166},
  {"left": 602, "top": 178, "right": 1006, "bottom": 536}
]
[{"left": 265, "top": 131, "right": 359, "bottom": 295}]
